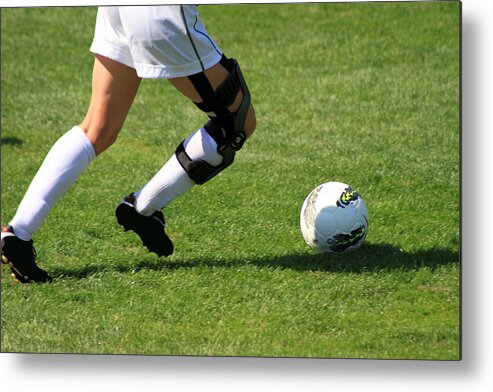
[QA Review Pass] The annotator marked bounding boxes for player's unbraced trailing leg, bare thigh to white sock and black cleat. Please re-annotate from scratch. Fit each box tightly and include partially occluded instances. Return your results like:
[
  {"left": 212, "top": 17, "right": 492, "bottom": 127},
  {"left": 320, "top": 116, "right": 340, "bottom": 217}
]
[{"left": 1, "top": 56, "right": 140, "bottom": 282}]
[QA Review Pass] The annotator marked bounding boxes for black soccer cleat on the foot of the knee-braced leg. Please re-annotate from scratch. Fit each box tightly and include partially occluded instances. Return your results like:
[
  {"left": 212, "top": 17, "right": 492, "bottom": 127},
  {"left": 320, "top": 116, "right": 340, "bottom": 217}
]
[{"left": 115, "top": 193, "right": 173, "bottom": 256}]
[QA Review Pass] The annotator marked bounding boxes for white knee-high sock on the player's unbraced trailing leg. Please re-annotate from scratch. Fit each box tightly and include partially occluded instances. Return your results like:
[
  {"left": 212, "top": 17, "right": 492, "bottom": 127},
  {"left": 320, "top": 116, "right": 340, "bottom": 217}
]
[{"left": 9, "top": 127, "right": 96, "bottom": 241}]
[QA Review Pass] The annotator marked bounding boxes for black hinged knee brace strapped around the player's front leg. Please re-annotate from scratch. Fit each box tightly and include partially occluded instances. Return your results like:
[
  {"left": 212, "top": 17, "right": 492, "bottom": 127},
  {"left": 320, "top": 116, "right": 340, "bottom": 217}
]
[{"left": 175, "top": 55, "right": 251, "bottom": 184}]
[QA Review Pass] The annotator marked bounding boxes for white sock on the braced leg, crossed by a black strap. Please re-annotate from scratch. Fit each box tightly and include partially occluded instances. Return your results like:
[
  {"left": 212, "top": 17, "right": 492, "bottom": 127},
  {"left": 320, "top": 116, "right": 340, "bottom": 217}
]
[{"left": 135, "top": 128, "right": 223, "bottom": 216}]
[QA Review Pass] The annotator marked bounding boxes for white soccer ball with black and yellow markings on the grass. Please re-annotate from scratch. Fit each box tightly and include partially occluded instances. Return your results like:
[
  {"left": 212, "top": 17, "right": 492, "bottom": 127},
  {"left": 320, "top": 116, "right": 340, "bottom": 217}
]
[{"left": 300, "top": 182, "right": 368, "bottom": 252}]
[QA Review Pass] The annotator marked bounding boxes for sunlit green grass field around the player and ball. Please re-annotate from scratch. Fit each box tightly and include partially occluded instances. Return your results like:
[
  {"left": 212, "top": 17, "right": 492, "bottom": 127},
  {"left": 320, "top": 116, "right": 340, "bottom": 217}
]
[{"left": 1, "top": 2, "right": 460, "bottom": 360}]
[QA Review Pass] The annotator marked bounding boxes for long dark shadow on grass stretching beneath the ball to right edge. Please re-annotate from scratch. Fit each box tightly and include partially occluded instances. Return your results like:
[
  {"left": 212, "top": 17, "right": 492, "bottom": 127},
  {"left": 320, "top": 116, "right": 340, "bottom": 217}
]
[{"left": 51, "top": 244, "right": 459, "bottom": 279}]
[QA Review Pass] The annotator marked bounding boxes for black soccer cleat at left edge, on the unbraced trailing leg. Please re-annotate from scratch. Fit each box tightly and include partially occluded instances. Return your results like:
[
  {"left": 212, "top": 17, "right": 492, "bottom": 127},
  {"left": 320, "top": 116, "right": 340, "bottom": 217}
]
[{"left": 1, "top": 226, "right": 53, "bottom": 283}]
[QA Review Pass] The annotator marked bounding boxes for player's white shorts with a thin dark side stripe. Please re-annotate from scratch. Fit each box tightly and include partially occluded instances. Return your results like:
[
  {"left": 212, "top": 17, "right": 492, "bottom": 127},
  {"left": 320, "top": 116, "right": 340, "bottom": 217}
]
[{"left": 90, "top": 5, "right": 222, "bottom": 78}]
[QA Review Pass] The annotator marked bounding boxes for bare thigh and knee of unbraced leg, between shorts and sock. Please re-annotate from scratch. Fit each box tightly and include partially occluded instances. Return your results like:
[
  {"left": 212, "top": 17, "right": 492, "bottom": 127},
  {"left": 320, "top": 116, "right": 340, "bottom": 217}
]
[{"left": 79, "top": 55, "right": 141, "bottom": 154}]
